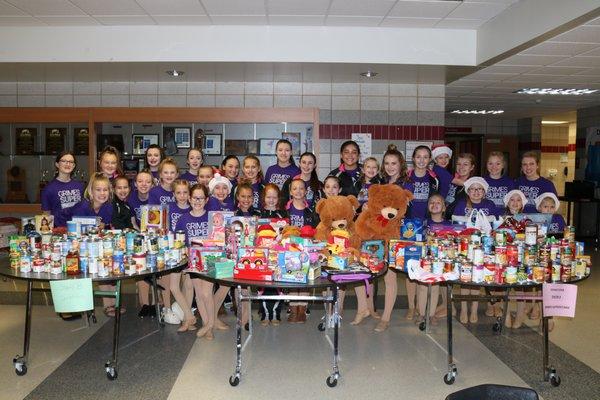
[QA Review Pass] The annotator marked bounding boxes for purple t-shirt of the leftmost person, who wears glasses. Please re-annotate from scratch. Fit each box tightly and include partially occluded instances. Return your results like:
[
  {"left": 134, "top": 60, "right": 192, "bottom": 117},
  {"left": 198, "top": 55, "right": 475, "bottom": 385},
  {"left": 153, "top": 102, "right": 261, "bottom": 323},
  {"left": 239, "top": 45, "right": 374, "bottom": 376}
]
[{"left": 41, "top": 178, "right": 84, "bottom": 226}]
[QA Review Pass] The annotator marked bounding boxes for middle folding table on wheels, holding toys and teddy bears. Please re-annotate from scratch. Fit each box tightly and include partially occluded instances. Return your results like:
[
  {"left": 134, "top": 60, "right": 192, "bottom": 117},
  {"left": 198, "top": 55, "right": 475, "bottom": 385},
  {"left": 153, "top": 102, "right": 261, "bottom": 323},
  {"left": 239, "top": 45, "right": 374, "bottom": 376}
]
[{"left": 190, "top": 269, "right": 386, "bottom": 387}]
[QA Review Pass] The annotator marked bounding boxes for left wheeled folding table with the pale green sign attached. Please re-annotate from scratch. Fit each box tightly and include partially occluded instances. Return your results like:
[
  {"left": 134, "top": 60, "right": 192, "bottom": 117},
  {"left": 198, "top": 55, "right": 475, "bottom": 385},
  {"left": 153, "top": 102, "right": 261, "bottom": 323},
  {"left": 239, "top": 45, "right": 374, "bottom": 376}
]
[{"left": 0, "top": 256, "right": 187, "bottom": 380}]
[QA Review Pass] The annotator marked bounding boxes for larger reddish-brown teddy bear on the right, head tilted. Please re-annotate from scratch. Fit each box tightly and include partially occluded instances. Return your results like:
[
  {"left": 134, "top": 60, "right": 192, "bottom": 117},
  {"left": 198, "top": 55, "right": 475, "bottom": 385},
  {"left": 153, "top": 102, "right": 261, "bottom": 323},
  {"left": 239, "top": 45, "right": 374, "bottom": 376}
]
[{"left": 356, "top": 184, "right": 413, "bottom": 244}]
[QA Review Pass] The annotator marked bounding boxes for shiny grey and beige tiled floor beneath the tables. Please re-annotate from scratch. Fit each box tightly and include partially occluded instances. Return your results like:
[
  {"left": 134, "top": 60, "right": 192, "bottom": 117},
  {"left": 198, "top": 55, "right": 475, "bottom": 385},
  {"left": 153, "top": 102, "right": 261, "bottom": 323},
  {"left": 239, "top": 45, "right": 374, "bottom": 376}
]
[{"left": 0, "top": 250, "right": 600, "bottom": 400}]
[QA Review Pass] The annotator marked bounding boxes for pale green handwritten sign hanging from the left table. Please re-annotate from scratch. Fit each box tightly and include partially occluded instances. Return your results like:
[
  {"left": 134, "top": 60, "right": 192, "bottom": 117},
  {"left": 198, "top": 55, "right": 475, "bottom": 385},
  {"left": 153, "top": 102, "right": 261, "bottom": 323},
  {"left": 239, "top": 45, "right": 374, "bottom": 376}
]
[{"left": 50, "top": 278, "right": 94, "bottom": 313}]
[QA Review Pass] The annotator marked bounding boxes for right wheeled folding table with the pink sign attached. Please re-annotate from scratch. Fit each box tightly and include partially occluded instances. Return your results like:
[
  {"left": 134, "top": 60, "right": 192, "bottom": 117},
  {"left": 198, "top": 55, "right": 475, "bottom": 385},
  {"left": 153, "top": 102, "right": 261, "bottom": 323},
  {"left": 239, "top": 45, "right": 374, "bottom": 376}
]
[{"left": 440, "top": 275, "right": 589, "bottom": 386}]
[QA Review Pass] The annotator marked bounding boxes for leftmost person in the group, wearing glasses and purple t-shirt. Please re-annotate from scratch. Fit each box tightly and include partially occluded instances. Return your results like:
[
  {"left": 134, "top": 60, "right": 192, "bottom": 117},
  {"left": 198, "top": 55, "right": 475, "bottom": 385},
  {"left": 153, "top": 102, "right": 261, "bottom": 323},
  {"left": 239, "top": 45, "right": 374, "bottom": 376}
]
[{"left": 41, "top": 151, "right": 84, "bottom": 227}]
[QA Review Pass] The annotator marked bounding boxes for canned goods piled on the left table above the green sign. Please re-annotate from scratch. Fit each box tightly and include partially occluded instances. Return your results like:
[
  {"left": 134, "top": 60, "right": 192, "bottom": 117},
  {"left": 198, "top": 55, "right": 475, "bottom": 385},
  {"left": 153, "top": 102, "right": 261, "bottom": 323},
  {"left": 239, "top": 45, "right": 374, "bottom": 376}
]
[{"left": 9, "top": 230, "right": 186, "bottom": 277}]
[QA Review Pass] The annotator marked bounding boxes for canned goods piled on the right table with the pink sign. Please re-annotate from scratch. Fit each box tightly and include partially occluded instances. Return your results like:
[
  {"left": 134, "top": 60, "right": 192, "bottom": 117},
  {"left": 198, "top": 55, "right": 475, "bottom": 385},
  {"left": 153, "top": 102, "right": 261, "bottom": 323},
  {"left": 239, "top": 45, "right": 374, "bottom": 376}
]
[{"left": 421, "top": 224, "right": 590, "bottom": 285}]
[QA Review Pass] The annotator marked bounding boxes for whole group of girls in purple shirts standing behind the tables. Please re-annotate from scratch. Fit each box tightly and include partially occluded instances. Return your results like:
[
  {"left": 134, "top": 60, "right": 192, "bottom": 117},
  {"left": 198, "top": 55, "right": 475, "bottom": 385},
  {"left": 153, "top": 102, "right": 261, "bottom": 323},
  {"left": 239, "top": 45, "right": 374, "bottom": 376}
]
[{"left": 42, "top": 139, "right": 564, "bottom": 339}]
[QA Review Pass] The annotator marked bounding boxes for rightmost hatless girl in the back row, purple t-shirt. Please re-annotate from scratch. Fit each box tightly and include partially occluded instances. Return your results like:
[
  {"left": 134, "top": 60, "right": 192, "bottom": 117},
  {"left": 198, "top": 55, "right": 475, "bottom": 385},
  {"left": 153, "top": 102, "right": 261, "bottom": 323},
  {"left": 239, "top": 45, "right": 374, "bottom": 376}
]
[{"left": 515, "top": 151, "right": 556, "bottom": 213}]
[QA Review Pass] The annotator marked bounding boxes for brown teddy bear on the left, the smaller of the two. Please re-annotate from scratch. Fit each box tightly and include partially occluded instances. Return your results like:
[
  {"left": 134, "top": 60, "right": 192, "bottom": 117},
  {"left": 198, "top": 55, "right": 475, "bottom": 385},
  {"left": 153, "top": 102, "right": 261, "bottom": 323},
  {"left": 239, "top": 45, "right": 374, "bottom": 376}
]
[{"left": 315, "top": 196, "right": 360, "bottom": 249}]
